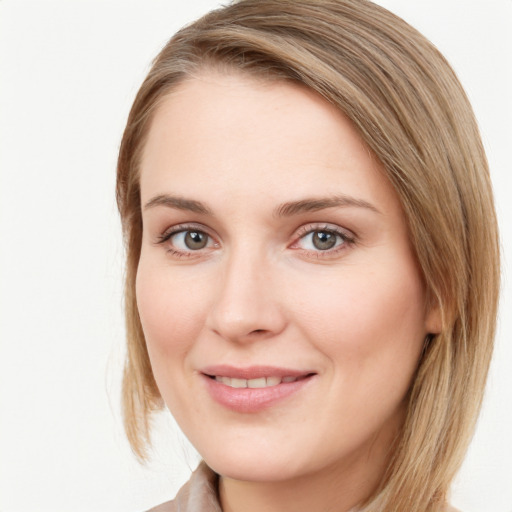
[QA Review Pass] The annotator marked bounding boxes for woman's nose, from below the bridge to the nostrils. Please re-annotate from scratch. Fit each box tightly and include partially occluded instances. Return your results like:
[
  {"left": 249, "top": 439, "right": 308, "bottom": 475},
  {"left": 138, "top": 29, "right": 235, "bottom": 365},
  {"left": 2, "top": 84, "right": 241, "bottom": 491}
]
[{"left": 207, "top": 249, "right": 286, "bottom": 343}]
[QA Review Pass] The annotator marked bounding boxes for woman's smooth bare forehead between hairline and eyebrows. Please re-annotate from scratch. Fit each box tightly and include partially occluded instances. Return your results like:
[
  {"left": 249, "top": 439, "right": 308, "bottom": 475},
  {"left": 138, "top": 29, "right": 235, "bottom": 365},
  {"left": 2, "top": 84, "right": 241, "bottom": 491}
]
[{"left": 141, "top": 72, "right": 396, "bottom": 212}]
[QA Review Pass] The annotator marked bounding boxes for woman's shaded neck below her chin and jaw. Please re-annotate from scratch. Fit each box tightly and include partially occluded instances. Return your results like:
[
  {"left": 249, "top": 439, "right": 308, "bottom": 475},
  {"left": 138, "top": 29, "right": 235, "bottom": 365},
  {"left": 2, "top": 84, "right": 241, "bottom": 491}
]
[{"left": 219, "top": 426, "right": 394, "bottom": 512}]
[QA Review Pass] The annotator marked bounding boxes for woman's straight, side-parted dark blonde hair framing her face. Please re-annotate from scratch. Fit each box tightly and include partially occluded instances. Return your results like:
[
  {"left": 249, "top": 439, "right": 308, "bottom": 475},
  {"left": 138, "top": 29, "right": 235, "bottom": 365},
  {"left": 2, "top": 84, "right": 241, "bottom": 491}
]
[{"left": 117, "top": 0, "right": 499, "bottom": 512}]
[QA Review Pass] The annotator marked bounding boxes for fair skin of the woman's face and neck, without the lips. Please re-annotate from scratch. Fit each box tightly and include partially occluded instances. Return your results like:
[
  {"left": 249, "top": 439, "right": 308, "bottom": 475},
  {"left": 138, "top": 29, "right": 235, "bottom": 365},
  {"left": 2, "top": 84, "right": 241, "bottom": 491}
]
[{"left": 136, "top": 71, "right": 439, "bottom": 512}]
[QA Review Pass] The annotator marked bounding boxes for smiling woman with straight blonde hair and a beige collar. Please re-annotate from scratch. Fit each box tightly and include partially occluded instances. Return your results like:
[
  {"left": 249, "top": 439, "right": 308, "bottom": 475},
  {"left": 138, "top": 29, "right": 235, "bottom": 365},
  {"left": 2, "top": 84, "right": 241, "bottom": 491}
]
[{"left": 117, "top": 0, "right": 499, "bottom": 512}]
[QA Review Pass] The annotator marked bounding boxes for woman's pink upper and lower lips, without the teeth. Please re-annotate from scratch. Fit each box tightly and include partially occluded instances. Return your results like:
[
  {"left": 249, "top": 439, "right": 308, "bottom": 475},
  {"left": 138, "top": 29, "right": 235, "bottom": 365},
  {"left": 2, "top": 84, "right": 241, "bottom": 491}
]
[{"left": 200, "top": 365, "right": 316, "bottom": 413}]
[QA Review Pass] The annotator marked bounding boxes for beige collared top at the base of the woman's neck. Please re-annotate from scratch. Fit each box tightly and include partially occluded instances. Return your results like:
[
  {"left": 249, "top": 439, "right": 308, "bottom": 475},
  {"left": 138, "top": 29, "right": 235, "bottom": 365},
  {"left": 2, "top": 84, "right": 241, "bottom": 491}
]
[{"left": 148, "top": 462, "right": 459, "bottom": 512}]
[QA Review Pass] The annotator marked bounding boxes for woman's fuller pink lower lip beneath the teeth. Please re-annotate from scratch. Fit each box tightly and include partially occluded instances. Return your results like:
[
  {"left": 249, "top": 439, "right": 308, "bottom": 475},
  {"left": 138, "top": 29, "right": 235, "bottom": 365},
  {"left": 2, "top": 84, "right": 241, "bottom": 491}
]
[{"left": 203, "top": 374, "right": 314, "bottom": 413}]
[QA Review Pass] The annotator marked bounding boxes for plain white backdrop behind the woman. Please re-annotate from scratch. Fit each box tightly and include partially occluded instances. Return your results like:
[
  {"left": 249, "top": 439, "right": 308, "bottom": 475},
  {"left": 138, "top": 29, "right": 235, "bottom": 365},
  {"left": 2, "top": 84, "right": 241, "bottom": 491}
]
[{"left": 0, "top": 0, "right": 512, "bottom": 512}]
